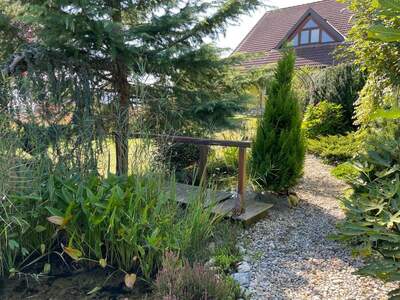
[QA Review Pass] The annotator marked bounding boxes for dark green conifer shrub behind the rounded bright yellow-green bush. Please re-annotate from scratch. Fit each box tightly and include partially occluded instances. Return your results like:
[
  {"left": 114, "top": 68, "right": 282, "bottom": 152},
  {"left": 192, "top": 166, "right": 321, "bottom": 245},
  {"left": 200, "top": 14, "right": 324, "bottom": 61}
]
[{"left": 308, "top": 64, "right": 365, "bottom": 130}]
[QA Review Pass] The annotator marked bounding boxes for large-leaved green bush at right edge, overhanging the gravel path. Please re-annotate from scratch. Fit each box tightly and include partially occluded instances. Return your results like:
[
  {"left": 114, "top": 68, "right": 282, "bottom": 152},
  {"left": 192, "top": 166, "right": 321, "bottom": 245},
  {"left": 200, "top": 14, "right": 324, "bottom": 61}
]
[{"left": 335, "top": 136, "right": 400, "bottom": 281}]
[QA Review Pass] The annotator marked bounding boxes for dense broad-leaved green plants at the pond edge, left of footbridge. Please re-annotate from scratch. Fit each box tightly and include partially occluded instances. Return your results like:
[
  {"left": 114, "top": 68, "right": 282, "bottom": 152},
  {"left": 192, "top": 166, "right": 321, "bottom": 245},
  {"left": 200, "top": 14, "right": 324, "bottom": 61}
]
[{"left": 0, "top": 174, "right": 217, "bottom": 279}]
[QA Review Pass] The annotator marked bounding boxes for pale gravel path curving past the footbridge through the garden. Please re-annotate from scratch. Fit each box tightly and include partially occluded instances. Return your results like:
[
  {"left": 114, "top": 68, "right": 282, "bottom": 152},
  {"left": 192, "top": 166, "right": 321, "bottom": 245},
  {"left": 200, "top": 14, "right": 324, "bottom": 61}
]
[{"left": 242, "top": 156, "right": 396, "bottom": 299}]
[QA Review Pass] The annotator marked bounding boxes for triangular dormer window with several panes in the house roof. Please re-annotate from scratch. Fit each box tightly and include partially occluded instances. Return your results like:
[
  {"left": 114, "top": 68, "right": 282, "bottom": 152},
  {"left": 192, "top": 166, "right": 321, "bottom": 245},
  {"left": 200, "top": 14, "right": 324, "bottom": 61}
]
[{"left": 289, "top": 18, "right": 334, "bottom": 47}]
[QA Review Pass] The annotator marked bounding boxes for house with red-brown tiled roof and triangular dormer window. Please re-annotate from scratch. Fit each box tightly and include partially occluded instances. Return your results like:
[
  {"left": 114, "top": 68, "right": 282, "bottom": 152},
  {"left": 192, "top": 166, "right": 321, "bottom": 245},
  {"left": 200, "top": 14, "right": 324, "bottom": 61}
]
[{"left": 234, "top": 0, "right": 351, "bottom": 68}]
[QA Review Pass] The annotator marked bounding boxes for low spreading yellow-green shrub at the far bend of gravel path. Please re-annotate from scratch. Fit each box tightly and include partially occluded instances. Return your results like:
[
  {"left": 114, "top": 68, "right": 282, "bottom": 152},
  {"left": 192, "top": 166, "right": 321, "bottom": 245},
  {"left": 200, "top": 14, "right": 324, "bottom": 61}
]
[{"left": 307, "top": 133, "right": 363, "bottom": 164}]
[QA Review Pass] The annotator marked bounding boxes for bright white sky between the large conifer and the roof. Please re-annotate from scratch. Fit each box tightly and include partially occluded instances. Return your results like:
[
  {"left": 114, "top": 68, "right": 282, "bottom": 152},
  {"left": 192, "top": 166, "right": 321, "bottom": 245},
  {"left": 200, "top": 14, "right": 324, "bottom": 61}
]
[{"left": 215, "top": 0, "right": 317, "bottom": 52}]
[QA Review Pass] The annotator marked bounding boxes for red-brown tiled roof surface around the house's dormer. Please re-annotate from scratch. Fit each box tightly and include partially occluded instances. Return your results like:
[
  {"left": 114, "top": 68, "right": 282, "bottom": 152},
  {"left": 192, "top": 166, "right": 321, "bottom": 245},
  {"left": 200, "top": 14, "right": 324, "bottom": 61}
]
[{"left": 235, "top": 0, "right": 351, "bottom": 67}]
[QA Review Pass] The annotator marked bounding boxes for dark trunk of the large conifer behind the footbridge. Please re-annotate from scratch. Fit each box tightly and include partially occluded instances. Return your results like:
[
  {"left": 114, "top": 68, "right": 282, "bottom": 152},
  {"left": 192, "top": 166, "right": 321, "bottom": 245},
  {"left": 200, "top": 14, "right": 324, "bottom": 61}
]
[{"left": 110, "top": 0, "right": 129, "bottom": 175}]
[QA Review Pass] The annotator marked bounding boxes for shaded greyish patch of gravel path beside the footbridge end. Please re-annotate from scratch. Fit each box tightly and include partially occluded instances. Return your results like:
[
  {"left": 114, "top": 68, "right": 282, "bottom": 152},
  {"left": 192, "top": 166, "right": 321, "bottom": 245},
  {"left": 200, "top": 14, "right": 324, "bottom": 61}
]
[{"left": 246, "top": 191, "right": 359, "bottom": 299}]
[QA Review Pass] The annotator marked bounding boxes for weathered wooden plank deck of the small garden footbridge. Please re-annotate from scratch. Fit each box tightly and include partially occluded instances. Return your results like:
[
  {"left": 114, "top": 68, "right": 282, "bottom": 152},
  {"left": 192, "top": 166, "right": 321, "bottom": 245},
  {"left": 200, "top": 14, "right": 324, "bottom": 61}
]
[{"left": 170, "top": 183, "right": 273, "bottom": 226}]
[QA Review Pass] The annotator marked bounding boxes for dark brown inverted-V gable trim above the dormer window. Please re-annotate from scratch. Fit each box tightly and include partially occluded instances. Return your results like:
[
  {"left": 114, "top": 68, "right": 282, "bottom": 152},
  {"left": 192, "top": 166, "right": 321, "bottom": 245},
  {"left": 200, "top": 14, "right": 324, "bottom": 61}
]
[{"left": 274, "top": 7, "right": 344, "bottom": 49}]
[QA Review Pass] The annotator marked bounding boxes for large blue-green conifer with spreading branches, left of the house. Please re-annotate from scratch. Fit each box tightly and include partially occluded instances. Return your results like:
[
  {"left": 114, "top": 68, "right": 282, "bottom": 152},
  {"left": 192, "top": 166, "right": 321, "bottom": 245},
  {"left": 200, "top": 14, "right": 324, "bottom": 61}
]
[{"left": 0, "top": 0, "right": 259, "bottom": 175}]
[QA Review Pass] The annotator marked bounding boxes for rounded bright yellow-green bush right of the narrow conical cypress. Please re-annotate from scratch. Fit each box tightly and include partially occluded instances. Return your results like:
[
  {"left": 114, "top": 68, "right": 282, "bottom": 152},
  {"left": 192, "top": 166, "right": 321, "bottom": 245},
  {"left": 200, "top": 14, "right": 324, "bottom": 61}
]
[{"left": 302, "top": 101, "right": 345, "bottom": 138}]
